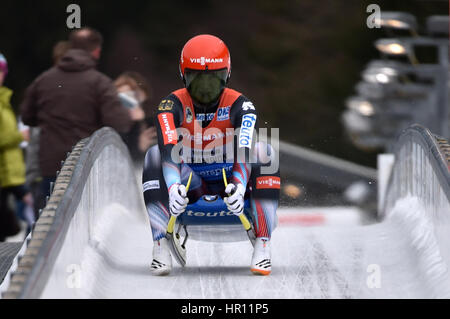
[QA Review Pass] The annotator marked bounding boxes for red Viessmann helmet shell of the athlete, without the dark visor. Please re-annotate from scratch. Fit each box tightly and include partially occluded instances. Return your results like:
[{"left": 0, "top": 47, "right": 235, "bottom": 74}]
[{"left": 180, "top": 34, "right": 231, "bottom": 80}]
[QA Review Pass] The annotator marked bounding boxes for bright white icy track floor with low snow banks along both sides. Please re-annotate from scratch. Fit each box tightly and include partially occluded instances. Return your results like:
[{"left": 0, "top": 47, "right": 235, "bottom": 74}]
[{"left": 42, "top": 198, "right": 450, "bottom": 299}]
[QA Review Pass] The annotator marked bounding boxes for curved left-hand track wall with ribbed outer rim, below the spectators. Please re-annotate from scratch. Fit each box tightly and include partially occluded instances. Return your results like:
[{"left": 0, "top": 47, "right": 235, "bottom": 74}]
[{"left": 3, "top": 128, "right": 148, "bottom": 298}]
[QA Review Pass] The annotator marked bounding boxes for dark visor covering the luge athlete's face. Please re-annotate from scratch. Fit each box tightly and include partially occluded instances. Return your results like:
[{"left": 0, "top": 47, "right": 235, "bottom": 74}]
[{"left": 184, "top": 68, "right": 228, "bottom": 104}]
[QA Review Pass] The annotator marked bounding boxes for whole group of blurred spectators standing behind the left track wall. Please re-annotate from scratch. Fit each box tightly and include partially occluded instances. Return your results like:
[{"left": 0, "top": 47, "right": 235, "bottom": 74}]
[{"left": 0, "top": 28, "right": 156, "bottom": 241}]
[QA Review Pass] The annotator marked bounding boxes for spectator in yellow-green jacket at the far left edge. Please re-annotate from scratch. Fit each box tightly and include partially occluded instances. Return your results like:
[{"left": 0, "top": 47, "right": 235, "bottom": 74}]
[{"left": 0, "top": 54, "right": 34, "bottom": 241}]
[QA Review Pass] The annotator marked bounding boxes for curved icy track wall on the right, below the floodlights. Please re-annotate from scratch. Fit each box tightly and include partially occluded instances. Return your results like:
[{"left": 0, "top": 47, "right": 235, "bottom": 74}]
[{"left": 380, "top": 124, "right": 450, "bottom": 298}]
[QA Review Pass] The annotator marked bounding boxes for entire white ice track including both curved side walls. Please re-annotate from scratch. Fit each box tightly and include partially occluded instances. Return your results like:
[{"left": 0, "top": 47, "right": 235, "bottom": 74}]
[{"left": 2, "top": 127, "right": 450, "bottom": 299}]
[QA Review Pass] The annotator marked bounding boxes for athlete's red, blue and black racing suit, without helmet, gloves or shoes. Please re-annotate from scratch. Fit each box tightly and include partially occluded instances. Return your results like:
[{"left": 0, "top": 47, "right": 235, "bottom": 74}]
[{"left": 142, "top": 88, "right": 280, "bottom": 241}]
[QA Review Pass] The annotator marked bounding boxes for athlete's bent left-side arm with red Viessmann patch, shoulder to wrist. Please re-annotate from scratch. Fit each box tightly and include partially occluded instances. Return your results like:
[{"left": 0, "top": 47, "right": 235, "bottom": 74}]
[{"left": 155, "top": 94, "right": 183, "bottom": 189}]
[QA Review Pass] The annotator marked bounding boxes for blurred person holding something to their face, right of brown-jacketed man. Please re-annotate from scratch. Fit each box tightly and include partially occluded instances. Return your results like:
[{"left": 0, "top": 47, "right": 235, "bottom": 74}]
[{"left": 114, "top": 72, "right": 157, "bottom": 164}]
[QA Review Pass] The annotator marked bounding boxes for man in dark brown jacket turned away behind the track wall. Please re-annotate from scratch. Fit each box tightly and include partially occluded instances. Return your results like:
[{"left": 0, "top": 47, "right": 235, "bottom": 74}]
[{"left": 21, "top": 28, "right": 138, "bottom": 210}]
